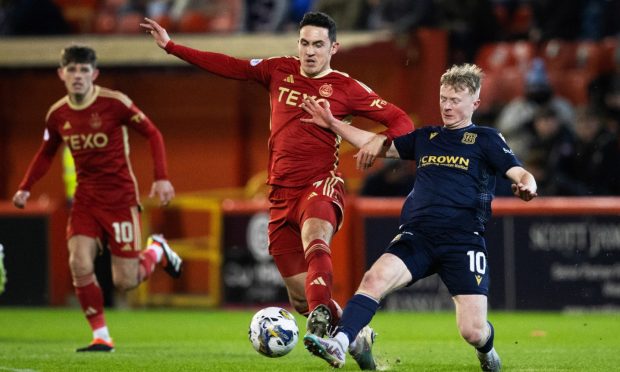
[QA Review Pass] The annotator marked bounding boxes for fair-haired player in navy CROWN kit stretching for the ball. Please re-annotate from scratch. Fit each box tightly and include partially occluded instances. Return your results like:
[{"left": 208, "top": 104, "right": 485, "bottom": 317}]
[{"left": 302, "top": 64, "right": 537, "bottom": 371}]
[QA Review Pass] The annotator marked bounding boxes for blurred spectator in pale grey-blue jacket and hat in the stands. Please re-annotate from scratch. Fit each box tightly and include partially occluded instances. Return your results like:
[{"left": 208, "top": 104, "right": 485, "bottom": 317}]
[{"left": 496, "top": 58, "right": 574, "bottom": 159}]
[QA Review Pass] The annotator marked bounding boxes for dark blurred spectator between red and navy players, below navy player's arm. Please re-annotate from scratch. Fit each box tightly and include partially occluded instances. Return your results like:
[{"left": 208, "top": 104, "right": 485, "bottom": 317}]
[{"left": 360, "top": 159, "right": 415, "bottom": 197}]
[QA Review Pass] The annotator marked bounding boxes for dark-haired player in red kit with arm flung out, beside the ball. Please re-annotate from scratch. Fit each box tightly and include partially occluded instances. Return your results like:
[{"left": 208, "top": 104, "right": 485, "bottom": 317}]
[{"left": 141, "top": 12, "right": 413, "bottom": 368}]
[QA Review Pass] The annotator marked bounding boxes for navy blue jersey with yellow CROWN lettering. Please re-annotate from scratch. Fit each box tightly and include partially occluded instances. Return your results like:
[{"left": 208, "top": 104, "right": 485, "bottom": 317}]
[{"left": 394, "top": 124, "right": 521, "bottom": 232}]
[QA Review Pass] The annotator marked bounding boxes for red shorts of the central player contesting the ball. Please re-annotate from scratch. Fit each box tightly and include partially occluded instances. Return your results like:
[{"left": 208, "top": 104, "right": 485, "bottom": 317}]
[{"left": 268, "top": 175, "right": 344, "bottom": 278}]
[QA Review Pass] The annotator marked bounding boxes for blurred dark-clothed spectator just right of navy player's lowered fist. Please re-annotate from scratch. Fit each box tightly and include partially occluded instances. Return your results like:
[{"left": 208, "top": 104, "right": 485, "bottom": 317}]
[{"left": 525, "top": 106, "right": 575, "bottom": 196}]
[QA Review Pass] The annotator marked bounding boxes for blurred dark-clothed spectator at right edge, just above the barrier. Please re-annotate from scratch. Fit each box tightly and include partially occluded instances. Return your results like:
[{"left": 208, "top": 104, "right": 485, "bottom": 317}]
[{"left": 565, "top": 107, "right": 620, "bottom": 196}]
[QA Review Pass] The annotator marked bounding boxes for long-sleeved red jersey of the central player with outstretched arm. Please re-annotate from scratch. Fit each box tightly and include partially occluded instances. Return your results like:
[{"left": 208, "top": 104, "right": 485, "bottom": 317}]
[{"left": 166, "top": 41, "right": 413, "bottom": 187}]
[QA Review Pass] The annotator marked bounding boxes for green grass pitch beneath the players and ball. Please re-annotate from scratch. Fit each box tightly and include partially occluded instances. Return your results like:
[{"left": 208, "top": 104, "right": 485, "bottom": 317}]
[{"left": 0, "top": 308, "right": 620, "bottom": 372}]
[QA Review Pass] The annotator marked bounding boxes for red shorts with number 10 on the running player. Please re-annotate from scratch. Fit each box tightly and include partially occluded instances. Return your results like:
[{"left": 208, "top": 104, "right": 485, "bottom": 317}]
[{"left": 67, "top": 203, "right": 142, "bottom": 258}]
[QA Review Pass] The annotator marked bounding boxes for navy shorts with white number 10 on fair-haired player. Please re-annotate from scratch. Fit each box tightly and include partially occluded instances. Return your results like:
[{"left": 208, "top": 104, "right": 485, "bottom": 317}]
[{"left": 386, "top": 230, "right": 490, "bottom": 296}]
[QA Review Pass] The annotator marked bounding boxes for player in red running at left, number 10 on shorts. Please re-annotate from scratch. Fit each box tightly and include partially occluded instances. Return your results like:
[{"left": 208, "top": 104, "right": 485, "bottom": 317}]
[{"left": 13, "top": 46, "right": 182, "bottom": 351}]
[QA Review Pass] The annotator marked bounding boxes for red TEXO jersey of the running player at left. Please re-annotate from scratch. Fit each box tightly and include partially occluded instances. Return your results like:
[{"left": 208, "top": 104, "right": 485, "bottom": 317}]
[{"left": 19, "top": 86, "right": 167, "bottom": 209}]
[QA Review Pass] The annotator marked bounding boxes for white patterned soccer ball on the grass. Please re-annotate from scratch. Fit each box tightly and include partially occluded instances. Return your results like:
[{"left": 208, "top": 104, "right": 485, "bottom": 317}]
[{"left": 248, "top": 307, "right": 299, "bottom": 358}]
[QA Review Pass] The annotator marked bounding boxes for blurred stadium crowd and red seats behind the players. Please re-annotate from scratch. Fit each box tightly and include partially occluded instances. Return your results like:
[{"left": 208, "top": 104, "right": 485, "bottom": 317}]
[{"left": 0, "top": 0, "right": 620, "bottom": 196}]
